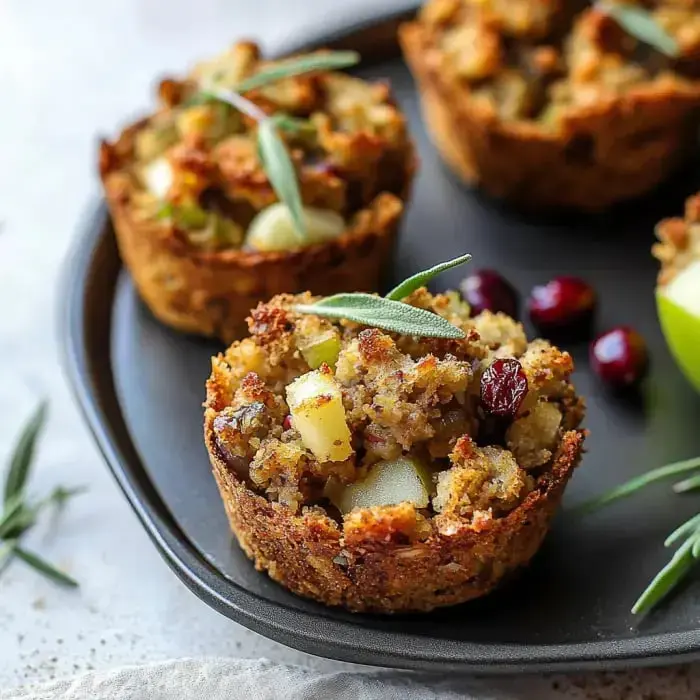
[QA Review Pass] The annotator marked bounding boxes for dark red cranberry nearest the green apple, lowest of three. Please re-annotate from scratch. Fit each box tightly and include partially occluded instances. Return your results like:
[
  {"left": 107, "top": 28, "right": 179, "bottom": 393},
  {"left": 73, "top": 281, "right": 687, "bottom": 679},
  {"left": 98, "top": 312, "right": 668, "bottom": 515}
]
[{"left": 590, "top": 326, "right": 647, "bottom": 387}]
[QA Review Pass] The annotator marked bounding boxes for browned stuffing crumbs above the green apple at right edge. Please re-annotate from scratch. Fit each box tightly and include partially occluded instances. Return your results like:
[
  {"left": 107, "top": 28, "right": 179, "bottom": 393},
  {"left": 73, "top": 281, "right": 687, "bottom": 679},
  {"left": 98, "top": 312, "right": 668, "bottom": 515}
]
[{"left": 653, "top": 194, "right": 700, "bottom": 287}]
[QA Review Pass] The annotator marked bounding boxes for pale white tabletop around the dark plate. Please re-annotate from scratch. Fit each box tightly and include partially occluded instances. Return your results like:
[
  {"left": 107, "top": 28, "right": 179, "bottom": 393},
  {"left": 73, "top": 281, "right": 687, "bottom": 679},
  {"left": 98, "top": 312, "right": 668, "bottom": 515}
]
[{"left": 0, "top": 0, "right": 700, "bottom": 698}]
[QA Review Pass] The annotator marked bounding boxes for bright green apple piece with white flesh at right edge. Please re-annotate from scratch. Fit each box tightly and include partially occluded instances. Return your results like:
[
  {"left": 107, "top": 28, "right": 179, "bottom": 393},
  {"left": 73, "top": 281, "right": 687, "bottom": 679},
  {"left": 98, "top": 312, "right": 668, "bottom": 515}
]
[{"left": 656, "top": 260, "right": 700, "bottom": 391}]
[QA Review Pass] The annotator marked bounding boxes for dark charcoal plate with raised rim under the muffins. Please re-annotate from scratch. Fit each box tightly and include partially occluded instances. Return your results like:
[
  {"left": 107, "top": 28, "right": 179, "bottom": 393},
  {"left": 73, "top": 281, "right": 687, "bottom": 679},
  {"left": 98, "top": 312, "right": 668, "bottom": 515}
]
[{"left": 62, "top": 5, "right": 700, "bottom": 672}]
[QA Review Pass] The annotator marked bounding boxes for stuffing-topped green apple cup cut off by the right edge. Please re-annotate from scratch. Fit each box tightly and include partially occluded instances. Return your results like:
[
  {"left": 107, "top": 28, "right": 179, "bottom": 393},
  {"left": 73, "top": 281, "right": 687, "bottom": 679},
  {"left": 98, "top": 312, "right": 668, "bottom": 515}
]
[{"left": 653, "top": 195, "right": 700, "bottom": 391}]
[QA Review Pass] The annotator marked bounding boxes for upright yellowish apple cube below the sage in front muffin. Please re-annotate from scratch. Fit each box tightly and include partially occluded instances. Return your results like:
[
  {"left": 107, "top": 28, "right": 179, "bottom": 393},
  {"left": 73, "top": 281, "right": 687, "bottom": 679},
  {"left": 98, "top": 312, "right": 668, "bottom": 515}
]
[{"left": 287, "top": 366, "right": 352, "bottom": 462}]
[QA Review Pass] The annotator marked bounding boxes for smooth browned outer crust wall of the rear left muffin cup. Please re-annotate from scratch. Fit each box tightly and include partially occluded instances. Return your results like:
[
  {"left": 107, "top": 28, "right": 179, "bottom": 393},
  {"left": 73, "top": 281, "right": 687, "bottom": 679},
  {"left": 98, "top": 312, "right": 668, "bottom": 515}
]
[{"left": 106, "top": 180, "right": 403, "bottom": 343}]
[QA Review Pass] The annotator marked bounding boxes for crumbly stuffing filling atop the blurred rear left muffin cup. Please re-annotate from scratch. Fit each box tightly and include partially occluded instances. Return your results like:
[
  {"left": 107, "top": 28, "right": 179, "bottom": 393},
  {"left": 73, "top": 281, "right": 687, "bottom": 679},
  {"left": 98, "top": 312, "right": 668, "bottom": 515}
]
[{"left": 100, "top": 42, "right": 413, "bottom": 249}]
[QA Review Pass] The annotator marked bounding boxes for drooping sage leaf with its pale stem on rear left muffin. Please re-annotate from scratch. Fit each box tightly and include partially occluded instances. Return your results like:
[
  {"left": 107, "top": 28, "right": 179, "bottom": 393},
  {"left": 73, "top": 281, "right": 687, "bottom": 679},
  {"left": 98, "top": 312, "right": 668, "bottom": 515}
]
[{"left": 207, "top": 89, "right": 306, "bottom": 243}]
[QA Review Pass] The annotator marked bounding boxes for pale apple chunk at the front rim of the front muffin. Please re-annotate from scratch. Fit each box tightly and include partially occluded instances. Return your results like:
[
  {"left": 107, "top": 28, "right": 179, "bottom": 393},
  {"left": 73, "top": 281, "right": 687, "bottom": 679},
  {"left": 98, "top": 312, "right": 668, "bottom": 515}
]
[{"left": 326, "top": 457, "right": 432, "bottom": 514}]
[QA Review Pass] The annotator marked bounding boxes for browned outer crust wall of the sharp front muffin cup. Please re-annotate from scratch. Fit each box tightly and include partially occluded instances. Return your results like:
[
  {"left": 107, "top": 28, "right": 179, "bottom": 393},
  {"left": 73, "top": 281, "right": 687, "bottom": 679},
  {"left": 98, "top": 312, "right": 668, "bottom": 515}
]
[{"left": 205, "top": 421, "right": 583, "bottom": 613}]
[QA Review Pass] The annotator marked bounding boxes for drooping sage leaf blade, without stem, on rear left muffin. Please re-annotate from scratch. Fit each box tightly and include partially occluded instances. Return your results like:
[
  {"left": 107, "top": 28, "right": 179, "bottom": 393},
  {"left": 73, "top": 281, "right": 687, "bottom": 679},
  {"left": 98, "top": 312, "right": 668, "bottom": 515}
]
[{"left": 258, "top": 119, "right": 306, "bottom": 242}]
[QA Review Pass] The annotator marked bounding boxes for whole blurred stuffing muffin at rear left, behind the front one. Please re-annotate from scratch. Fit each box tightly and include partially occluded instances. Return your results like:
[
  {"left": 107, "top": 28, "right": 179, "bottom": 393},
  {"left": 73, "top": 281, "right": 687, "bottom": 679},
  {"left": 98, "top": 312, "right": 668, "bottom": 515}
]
[{"left": 100, "top": 43, "right": 416, "bottom": 342}]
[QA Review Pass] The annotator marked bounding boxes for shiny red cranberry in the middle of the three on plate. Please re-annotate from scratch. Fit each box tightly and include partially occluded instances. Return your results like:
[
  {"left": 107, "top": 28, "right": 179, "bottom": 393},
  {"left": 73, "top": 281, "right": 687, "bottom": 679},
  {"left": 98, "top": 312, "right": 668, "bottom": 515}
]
[{"left": 528, "top": 277, "right": 596, "bottom": 335}]
